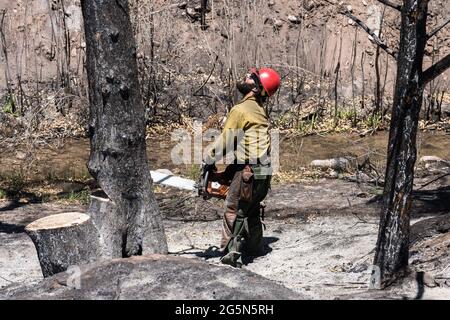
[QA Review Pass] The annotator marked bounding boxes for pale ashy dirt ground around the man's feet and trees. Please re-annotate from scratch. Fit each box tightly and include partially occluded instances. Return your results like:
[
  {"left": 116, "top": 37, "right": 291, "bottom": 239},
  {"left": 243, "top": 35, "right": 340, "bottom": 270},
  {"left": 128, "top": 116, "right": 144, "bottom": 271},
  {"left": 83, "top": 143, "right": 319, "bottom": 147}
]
[{"left": 0, "top": 174, "right": 450, "bottom": 299}]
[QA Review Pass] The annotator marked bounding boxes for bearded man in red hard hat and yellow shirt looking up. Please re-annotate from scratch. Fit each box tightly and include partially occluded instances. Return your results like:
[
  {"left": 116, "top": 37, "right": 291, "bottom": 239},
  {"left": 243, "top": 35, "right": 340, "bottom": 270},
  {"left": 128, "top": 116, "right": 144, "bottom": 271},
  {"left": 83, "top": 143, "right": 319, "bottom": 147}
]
[{"left": 203, "top": 68, "right": 280, "bottom": 268}]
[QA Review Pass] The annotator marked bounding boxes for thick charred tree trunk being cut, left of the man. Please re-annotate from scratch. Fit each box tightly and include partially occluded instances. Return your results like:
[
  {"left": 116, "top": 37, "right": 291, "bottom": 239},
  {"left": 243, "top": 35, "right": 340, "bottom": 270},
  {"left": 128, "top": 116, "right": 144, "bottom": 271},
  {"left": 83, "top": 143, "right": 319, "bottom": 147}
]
[{"left": 81, "top": 0, "right": 167, "bottom": 257}]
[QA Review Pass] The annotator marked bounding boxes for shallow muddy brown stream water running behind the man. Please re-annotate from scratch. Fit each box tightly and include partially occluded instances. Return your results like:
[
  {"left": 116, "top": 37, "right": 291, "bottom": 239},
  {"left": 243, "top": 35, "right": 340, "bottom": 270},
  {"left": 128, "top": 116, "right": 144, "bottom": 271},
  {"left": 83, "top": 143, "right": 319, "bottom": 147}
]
[{"left": 0, "top": 132, "right": 450, "bottom": 180}]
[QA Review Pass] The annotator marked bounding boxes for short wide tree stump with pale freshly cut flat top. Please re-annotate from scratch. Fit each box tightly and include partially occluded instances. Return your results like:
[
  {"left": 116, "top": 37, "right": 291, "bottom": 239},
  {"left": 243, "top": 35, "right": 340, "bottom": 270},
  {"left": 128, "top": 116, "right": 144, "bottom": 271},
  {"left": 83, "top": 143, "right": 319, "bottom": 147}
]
[{"left": 25, "top": 212, "right": 99, "bottom": 277}]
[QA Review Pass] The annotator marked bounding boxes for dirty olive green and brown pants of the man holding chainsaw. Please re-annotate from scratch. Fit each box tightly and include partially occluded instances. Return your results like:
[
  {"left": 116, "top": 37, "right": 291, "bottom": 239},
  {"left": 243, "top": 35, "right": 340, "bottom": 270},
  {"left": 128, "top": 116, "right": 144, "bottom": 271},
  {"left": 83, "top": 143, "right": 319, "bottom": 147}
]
[{"left": 221, "top": 166, "right": 272, "bottom": 267}]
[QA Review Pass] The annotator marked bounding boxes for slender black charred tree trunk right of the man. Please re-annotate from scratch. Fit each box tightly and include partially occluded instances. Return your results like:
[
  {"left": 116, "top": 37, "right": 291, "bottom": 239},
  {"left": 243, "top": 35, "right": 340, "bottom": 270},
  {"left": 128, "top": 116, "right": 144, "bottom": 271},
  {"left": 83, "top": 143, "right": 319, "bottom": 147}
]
[{"left": 374, "top": 0, "right": 428, "bottom": 287}]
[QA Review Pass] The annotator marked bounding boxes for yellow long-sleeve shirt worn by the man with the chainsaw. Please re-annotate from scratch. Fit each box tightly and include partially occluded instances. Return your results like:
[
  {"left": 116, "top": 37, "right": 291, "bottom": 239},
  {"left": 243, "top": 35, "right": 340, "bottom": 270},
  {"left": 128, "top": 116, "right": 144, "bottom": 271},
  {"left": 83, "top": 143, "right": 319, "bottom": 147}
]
[{"left": 207, "top": 97, "right": 270, "bottom": 164}]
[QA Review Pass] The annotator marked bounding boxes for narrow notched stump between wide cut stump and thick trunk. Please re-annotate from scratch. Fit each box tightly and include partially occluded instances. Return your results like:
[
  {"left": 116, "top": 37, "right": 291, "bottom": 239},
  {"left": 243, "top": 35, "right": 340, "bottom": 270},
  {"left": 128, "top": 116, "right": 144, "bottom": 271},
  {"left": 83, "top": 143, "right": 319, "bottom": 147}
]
[{"left": 87, "top": 191, "right": 125, "bottom": 259}]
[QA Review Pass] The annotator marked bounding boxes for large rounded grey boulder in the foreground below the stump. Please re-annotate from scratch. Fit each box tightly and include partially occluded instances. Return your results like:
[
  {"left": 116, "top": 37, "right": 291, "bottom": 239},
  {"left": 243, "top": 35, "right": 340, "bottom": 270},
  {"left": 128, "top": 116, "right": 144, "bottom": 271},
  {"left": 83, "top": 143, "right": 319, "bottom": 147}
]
[{"left": 0, "top": 254, "right": 305, "bottom": 300}]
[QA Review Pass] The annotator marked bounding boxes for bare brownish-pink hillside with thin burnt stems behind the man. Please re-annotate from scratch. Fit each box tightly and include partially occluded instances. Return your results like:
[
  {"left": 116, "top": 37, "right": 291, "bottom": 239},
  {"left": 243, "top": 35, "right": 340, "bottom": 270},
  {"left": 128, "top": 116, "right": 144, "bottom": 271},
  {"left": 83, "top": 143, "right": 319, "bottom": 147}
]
[{"left": 0, "top": 0, "right": 450, "bottom": 136}]
